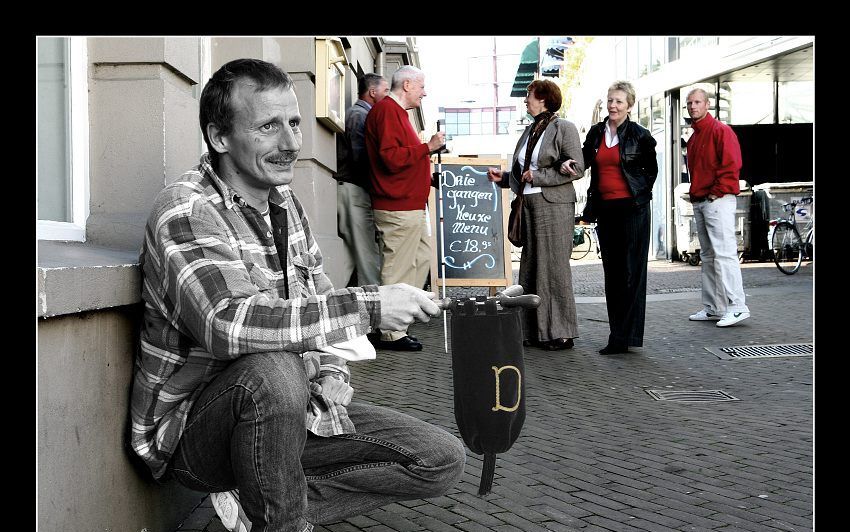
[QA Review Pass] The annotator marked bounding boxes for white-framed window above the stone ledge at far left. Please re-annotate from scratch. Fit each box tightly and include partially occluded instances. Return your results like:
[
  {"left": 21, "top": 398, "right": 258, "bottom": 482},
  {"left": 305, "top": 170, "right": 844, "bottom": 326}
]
[{"left": 36, "top": 37, "right": 88, "bottom": 242}]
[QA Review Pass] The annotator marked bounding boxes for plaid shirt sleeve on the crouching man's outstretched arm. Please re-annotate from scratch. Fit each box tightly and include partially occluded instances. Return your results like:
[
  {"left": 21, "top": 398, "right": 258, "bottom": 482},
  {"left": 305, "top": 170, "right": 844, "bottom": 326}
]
[{"left": 147, "top": 183, "right": 380, "bottom": 359}]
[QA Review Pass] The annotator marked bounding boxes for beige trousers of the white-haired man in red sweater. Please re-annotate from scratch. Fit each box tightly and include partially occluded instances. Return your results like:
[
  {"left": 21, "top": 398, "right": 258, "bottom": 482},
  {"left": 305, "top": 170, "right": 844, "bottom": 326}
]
[{"left": 374, "top": 209, "right": 432, "bottom": 342}]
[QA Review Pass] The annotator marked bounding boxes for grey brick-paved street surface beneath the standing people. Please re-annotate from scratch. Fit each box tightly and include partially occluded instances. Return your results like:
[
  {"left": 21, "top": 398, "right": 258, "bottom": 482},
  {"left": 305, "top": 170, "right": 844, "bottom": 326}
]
[{"left": 180, "top": 260, "right": 814, "bottom": 532}]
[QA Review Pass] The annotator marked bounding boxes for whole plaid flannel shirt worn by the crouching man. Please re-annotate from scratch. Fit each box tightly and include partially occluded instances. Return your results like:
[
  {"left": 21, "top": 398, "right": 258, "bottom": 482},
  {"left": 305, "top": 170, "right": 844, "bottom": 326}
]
[{"left": 130, "top": 154, "right": 381, "bottom": 478}]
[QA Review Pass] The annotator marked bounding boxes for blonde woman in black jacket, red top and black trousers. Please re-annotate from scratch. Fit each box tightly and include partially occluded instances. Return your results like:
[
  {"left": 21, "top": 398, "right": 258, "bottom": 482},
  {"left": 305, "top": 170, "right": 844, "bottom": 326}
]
[{"left": 568, "top": 81, "right": 658, "bottom": 355}]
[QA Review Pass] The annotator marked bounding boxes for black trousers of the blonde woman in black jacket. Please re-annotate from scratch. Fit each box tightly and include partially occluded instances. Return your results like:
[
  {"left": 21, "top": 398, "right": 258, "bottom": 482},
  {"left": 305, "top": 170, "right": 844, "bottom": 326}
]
[{"left": 596, "top": 198, "right": 650, "bottom": 347}]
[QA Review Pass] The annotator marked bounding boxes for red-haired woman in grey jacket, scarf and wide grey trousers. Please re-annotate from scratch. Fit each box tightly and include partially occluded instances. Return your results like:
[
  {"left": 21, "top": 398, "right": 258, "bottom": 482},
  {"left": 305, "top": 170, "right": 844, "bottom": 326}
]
[{"left": 487, "top": 79, "right": 584, "bottom": 351}]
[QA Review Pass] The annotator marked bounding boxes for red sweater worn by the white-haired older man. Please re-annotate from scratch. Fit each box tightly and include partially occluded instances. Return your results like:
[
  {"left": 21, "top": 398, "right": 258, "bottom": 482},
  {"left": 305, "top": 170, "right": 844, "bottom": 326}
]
[{"left": 365, "top": 97, "right": 431, "bottom": 211}]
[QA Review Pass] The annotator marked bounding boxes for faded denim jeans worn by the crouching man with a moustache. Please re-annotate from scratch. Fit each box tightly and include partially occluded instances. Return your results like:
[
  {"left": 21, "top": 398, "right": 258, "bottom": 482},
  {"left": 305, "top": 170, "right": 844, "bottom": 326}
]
[{"left": 170, "top": 352, "right": 465, "bottom": 532}]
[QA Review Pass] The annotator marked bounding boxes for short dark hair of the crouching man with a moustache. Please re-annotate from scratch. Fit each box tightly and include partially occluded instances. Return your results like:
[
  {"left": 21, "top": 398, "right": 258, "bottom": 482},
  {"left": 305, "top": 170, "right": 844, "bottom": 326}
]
[{"left": 199, "top": 59, "right": 292, "bottom": 165}]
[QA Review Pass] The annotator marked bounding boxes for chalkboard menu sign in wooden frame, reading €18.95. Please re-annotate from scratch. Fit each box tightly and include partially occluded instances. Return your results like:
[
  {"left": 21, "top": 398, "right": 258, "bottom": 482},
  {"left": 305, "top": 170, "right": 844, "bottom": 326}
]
[{"left": 430, "top": 157, "right": 506, "bottom": 286}]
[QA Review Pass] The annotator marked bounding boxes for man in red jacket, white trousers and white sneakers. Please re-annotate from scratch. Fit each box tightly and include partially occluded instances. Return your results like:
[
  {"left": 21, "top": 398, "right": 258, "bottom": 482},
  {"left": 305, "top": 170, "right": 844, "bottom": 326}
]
[{"left": 687, "top": 89, "right": 750, "bottom": 327}]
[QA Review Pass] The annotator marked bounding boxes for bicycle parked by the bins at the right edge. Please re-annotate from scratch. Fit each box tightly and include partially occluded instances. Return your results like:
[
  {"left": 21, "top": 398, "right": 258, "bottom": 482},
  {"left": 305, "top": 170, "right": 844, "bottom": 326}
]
[{"left": 769, "top": 196, "right": 815, "bottom": 275}]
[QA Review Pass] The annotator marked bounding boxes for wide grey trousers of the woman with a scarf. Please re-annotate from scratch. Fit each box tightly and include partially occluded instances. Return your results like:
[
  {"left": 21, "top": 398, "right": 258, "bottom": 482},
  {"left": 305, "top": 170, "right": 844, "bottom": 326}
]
[{"left": 519, "top": 194, "right": 578, "bottom": 342}]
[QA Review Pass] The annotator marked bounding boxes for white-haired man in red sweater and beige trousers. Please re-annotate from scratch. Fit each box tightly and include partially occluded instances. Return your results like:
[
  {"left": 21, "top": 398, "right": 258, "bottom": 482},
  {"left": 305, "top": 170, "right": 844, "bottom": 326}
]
[{"left": 365, "top": 65, "right": 446, "bottom": 351}]
